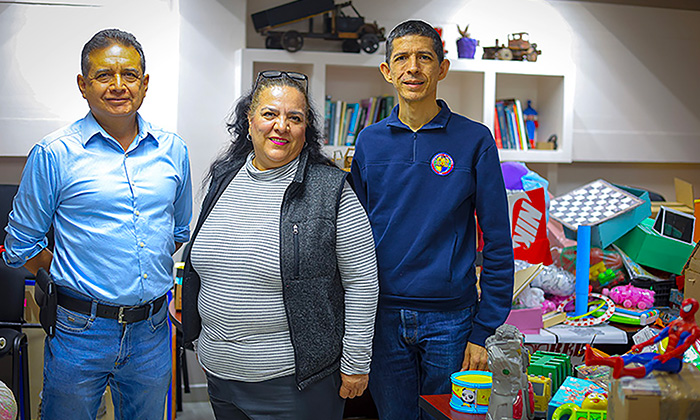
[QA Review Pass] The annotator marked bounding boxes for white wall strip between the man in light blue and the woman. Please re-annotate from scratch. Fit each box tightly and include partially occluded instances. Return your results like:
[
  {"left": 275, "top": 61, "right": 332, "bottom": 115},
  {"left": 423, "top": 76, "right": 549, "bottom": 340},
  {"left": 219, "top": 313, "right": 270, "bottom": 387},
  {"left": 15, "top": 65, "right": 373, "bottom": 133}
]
[{"left": 177, "top": 0, "right": 246, "bottom": 207}]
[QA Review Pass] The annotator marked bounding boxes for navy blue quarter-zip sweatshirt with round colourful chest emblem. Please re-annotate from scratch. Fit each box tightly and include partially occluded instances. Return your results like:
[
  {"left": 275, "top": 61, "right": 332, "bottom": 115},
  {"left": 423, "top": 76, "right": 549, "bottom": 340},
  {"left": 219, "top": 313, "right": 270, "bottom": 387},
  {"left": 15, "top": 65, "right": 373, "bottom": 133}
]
[{"left": 351, "top": 100, "right": 513, "bottom": 346}]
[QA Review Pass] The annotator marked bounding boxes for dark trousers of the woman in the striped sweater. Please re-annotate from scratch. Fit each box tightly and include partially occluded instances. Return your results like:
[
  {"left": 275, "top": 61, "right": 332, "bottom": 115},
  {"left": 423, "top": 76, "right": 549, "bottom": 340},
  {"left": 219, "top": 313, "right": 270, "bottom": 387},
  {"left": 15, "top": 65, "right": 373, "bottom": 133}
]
[{"left": 207, "top": 371, "right": 345, "bottom": 420}]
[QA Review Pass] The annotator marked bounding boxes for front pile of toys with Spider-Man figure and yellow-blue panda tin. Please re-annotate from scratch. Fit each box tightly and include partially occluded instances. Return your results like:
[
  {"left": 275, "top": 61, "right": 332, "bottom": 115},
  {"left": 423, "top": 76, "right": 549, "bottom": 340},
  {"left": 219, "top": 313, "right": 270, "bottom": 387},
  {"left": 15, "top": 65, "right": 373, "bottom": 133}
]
[{"left": 450, "top": 306, "right": 700, "bottom": 420}]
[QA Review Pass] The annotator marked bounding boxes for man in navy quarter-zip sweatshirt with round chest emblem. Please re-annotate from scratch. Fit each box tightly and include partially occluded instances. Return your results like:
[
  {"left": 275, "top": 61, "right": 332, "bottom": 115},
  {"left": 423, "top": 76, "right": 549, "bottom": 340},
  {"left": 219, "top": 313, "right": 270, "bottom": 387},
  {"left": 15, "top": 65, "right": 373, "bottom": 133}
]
[{"left": 351, "top": 20, "right": 513, "bottom": 420}]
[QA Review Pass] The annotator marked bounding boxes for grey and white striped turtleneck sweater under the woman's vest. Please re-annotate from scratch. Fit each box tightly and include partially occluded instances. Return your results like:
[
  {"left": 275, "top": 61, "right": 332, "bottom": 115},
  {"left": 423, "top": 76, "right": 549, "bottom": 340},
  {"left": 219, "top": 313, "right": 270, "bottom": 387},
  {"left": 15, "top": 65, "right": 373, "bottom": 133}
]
[{"left": 191, "top": 154, "right": 377, "bottom": 382}]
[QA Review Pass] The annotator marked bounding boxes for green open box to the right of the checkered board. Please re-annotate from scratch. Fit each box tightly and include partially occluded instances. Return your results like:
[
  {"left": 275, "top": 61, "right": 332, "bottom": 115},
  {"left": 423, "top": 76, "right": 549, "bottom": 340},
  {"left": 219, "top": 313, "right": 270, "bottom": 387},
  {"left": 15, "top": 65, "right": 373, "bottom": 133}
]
[{"left": 615, "top": 219, "right": 693, "bottom": 274}]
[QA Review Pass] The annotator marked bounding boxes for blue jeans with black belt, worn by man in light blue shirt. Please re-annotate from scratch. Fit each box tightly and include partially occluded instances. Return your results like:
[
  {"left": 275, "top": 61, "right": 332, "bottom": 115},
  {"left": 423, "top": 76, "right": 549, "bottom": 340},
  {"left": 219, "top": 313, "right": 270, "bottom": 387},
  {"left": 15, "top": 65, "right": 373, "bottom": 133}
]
[{"left": 41, "top": 296, "right": 171, "bottom": 420}]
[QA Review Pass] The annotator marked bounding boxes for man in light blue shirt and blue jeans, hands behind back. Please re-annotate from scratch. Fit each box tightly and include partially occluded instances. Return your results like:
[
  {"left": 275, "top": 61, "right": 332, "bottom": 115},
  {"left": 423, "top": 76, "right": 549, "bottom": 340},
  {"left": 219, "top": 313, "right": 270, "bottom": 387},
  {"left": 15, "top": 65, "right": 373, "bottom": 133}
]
[{"left": 3, "top": 29, "right": 192, "bottom": 420}]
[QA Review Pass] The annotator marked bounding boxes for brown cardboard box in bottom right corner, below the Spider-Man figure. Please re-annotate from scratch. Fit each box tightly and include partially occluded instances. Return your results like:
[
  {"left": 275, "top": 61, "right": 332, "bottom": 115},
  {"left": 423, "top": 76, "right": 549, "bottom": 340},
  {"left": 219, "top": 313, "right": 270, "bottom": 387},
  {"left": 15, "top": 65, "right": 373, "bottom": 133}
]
[{"left": 608, "top": 364, "right": 700, "bottom": 420}]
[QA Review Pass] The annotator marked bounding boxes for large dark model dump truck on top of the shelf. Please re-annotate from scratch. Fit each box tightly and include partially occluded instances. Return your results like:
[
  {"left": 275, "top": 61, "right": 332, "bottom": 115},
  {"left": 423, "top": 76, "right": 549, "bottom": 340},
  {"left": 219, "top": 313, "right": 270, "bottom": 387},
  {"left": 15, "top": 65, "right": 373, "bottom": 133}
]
[{"left": 251, "top": 0, "right": 386, "bottom": 54}]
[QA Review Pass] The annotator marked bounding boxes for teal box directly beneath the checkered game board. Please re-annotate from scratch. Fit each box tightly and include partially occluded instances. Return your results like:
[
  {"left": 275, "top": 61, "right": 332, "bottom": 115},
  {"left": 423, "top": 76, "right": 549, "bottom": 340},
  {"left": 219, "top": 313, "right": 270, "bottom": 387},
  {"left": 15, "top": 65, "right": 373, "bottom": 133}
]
[{"left": 564, "top": 184, "right": 651, "bottom": 249}]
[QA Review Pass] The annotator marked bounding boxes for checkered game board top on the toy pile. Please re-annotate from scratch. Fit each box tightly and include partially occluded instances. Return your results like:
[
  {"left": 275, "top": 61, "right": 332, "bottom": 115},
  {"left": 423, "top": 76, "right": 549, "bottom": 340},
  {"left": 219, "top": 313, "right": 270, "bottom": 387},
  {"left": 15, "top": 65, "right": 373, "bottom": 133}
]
[{"left": 549, "top": 179, "right": 644, "bottom": 231}]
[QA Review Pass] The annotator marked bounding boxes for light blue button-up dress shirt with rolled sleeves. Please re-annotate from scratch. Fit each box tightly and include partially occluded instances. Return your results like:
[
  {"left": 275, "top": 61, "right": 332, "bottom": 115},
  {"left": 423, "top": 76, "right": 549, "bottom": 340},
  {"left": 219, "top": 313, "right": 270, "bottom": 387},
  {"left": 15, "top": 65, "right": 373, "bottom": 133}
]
[{"left": 3, "top": 113, "right": 192, "bottom": 305}]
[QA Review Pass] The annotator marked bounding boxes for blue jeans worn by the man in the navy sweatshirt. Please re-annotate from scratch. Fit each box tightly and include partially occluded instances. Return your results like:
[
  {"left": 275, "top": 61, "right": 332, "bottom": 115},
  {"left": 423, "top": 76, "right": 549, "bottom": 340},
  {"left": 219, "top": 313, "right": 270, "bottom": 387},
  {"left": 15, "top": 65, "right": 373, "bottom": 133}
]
[{"left": 369, "top": 308, "right": 473, "bottom": 420}]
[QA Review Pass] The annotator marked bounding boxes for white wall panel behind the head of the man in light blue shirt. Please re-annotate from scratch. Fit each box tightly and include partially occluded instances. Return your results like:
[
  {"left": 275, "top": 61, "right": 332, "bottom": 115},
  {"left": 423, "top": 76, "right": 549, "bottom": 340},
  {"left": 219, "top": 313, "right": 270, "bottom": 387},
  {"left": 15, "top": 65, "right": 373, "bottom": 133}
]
[{"left": 0, "top": 0, "right": 179, "bottom": 156}]
